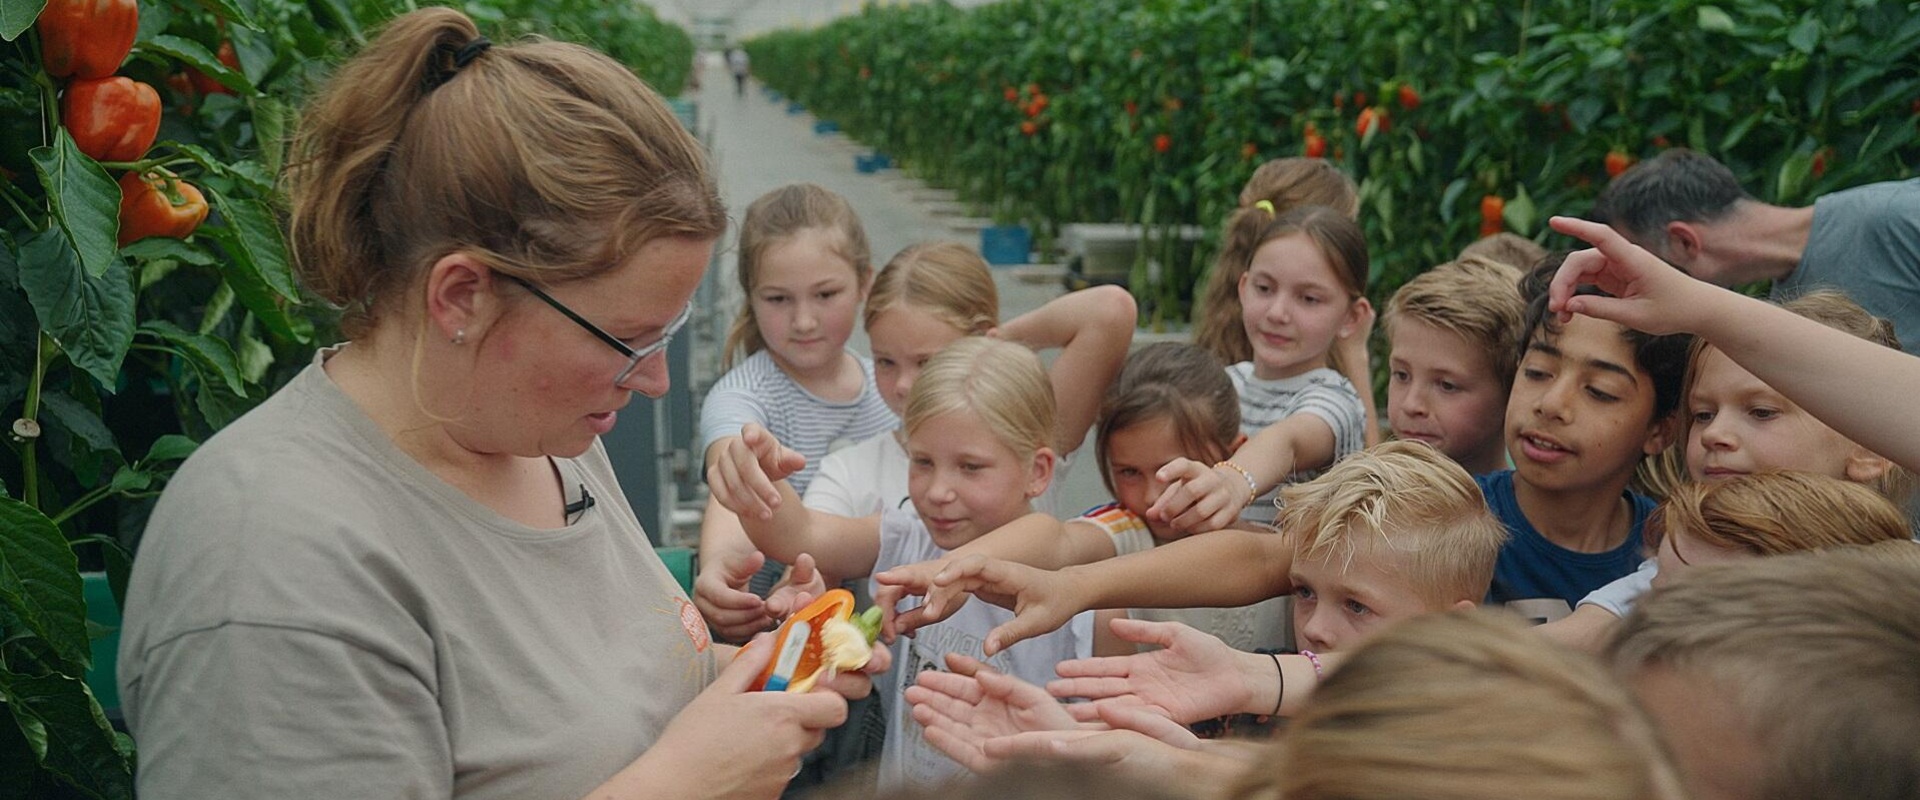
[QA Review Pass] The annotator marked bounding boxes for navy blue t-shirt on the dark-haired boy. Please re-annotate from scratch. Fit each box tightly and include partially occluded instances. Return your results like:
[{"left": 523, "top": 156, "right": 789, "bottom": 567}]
[{"left": 1475, "top": 470, "right": 1653, "bottom": 610}]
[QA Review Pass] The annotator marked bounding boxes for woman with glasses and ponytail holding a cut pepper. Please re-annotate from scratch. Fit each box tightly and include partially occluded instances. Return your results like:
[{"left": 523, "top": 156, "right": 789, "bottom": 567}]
[{"left": 119, "top": 8, "right": 885, "bottom": 798}]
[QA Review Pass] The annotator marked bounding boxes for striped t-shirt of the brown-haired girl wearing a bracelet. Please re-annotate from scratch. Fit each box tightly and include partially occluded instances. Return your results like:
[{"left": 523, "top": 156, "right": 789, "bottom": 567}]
[{"left": 1227, "top": 361, "right": 1367, "bottom": 526}]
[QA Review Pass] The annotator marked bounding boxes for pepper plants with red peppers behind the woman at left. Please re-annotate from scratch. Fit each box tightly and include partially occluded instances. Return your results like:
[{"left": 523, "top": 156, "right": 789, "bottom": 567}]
[{"left": 0, "top": 0, "right": 691, "bottom": 798}]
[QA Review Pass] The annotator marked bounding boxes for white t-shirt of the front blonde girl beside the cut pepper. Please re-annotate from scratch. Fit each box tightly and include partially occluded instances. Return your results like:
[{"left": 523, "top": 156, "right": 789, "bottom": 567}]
[{"left": 874, "top": 510, "right": 1092, "bottom": 790}]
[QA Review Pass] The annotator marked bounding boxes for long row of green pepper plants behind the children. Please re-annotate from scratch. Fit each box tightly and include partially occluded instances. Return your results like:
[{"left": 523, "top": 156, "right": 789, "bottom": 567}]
[{"left": 747, "top": 0, "right": 1920, "bottom": 320}]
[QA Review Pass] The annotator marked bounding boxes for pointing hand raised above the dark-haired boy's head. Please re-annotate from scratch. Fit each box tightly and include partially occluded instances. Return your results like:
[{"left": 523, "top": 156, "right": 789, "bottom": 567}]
[{"left": 1548, "top": 217, "right": 1713, "bottom": 334}]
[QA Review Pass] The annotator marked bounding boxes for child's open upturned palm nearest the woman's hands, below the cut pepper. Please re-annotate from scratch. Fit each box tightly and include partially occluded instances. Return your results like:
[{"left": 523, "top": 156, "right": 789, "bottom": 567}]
[{"left": 906, "top": 654, "right": 1079, "bottom": 771}]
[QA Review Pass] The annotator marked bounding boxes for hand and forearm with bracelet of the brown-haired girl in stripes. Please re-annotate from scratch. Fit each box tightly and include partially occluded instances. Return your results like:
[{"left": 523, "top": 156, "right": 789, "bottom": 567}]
[{"left": 1146, "top": 412, "right": 1338, "bottom": 531}]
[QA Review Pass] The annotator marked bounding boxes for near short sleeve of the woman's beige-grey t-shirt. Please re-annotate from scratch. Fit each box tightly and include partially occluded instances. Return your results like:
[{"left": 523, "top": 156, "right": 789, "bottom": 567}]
[{"left": 138, "top": 624, "right": 453, "bottom": 800}]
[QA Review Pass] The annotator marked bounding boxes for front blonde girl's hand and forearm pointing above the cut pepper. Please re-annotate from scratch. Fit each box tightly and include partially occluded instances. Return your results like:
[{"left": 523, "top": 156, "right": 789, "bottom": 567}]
[{"left": 708, "top": 424, "right": 879, "bottom": 579}]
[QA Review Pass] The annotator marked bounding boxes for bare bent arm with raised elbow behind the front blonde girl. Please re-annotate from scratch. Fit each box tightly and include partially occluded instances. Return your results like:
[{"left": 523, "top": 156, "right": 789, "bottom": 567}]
[{"left": 998, "top": 286, "right": 1139, "bottom": 457}]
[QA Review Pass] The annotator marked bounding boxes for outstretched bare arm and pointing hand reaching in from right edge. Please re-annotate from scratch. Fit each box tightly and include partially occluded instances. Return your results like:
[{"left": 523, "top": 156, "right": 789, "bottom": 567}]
[{"left": 1551, "top": 217, "right": 1920, "bottom": 470}]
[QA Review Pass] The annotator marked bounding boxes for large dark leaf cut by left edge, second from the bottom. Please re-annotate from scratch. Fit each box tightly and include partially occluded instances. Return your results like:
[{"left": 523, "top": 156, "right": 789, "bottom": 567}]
[{"left": 0, "top": 497, "right": 92, "bottom": 673}]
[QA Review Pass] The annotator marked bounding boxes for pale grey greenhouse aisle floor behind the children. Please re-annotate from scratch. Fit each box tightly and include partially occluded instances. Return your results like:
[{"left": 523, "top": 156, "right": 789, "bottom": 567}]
[{"left": 674, "top": 69, "right": 1106, "bottom": 537}]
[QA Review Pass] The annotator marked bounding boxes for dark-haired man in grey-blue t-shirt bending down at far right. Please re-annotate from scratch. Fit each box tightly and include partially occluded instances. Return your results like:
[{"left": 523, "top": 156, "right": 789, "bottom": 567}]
[{"left": 1594, "top": 148, "right": 1920, "bottom": 353}]
